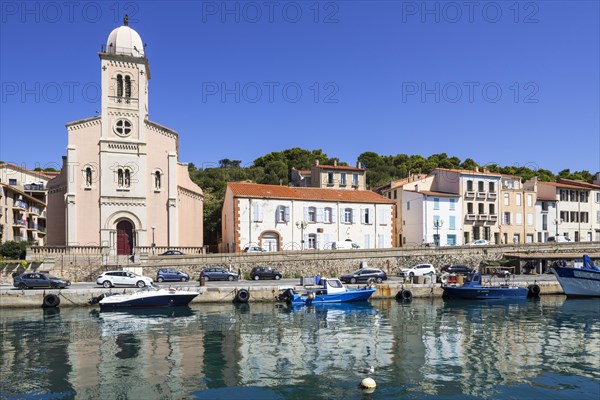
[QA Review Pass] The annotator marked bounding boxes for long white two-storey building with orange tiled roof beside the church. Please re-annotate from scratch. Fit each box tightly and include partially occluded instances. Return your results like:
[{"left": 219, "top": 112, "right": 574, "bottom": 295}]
[{"left": 221, "top": 182, "right": 395, "bottom": 252}]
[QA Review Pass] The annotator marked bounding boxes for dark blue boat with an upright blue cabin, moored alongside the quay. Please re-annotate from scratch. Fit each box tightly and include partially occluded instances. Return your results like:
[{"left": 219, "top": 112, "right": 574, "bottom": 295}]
[{"left": 442, "top": 273, "right": 529, "bottom": 300}]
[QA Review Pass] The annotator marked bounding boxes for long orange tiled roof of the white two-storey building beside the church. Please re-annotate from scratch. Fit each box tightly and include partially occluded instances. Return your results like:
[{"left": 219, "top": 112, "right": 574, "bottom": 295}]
[{"left": 227, "top": 182, "right": 395, "bottom": 204}]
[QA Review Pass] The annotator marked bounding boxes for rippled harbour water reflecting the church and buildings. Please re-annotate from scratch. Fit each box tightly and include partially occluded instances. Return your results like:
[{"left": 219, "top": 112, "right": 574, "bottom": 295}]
[{"left": 0, "top": 297, "right": 600, "bottom": 400}]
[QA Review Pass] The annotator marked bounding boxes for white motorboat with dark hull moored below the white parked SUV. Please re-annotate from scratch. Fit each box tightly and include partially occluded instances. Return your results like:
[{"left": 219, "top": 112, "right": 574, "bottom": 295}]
[{"left": 88, "top": 285, "right": 200, "bottom": 309}]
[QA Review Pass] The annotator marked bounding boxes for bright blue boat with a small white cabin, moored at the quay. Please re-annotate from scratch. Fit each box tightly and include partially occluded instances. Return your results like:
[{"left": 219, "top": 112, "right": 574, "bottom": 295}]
[{"left": 277, "top": 278, "right": 375, "bottom": 306}]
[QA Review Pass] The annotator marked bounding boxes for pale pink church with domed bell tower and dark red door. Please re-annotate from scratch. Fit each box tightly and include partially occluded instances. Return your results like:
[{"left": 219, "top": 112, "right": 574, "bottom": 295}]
[{"left": 47, "top": 16, "right": 203, "bottom": 255}]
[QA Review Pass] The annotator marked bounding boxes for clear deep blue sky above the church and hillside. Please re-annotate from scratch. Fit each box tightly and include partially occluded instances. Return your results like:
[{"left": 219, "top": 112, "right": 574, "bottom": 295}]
[{"left": 0, "top": 1, "right": 600, "bottom": 172}]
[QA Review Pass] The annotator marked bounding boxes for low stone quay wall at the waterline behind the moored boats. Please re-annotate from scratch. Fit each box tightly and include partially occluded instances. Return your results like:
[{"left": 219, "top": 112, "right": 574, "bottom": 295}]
[{"left": 0, "top": 281, "right": 563, "bottom": 309}]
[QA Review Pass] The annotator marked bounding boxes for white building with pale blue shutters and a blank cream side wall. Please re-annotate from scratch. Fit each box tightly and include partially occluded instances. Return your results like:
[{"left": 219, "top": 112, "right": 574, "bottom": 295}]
[{"left": 402, "top": 189, "right": 463, "bottom": 246}]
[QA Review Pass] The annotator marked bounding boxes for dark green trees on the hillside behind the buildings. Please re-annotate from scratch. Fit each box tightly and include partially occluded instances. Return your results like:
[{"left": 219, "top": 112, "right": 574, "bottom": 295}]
[{"left": 188, "top": 147, "right": 594, "bottom": 245}]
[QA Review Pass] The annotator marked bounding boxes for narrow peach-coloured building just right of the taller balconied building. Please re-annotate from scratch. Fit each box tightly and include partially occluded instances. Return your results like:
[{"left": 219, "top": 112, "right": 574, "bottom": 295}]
[{"left": 499, "top": 175, "right": 536, "bottom": 244}]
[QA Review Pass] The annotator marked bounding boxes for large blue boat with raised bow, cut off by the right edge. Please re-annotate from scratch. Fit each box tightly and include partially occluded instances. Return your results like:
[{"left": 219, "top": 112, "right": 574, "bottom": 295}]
[{"left": 552, "top": 255, "right": 600, "bottom": 297}]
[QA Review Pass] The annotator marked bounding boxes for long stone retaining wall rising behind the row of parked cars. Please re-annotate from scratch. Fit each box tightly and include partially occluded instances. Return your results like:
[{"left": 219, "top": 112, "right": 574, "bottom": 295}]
[{"left": 0, "top": 242, "right": 600, "bottom": 284}]
